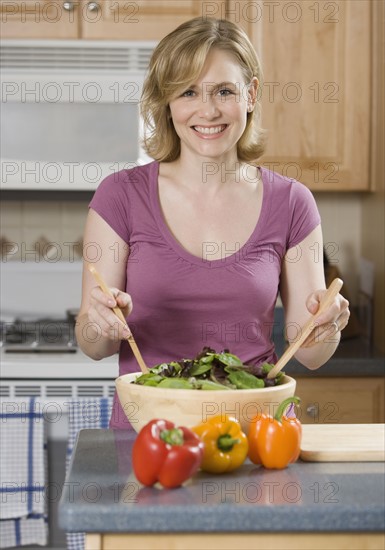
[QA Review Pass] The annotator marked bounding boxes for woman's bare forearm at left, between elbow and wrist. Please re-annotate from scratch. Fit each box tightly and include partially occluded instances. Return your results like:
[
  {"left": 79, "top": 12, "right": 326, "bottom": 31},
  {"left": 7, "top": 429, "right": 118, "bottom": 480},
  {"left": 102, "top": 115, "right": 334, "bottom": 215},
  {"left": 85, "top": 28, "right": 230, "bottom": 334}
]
[{"left": 75, "top": 313, "right": 120, "bottom": 361}]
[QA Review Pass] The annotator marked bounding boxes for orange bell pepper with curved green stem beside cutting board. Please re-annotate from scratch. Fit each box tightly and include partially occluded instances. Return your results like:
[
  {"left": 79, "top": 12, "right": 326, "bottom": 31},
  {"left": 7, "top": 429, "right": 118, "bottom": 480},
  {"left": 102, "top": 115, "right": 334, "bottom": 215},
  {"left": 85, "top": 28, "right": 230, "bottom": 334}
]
[{"left": 248, "top": 397, "right": 302, "bottom": 469}]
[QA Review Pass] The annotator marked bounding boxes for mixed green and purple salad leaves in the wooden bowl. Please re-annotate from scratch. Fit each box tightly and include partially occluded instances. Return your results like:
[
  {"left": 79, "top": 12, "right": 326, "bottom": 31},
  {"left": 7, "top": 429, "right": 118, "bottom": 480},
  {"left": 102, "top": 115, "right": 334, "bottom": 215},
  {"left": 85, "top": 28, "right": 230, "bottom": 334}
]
[{"left": 132, "top": 347, "right": 285, "bottom": 390}]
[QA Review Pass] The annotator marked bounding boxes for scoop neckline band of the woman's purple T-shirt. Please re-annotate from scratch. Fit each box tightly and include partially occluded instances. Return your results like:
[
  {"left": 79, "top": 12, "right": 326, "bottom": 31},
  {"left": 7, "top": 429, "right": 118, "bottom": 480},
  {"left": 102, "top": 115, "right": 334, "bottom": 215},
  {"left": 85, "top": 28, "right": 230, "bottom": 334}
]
[{"left": 150, "top": 161, "right": 270, "bottom": 269}]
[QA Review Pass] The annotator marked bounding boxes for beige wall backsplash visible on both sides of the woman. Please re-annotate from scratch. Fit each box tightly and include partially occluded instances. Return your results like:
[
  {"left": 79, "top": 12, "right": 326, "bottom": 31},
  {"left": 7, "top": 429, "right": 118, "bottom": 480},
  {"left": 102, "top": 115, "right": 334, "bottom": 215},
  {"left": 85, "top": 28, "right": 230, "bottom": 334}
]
[{"left": 0, "top": 193, "right": 362, "bottom": 302}]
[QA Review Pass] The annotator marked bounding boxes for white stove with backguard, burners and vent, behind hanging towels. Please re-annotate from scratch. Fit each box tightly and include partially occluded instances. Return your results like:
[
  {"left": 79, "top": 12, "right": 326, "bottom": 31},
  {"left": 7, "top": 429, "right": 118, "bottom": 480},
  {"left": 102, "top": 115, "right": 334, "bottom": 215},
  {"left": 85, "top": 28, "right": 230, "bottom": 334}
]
[{"left": 0, "top": 261, "right": 119, "bottom": 548}]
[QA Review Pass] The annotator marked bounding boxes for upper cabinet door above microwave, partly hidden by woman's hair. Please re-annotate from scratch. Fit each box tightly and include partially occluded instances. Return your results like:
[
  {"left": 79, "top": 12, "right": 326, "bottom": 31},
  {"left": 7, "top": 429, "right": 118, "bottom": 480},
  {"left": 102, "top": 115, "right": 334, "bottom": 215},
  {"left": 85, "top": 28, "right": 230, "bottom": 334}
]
[{"left": 81, "top": 0, "right": 226, "bottom": 40}]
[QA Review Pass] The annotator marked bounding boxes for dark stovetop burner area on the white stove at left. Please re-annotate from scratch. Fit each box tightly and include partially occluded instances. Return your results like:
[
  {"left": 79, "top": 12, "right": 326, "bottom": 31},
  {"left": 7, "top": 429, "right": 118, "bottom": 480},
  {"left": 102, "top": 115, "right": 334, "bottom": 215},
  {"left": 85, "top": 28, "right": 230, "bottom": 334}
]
[{"left": 0, "top": 318, "right": 77, "bottom": 353}]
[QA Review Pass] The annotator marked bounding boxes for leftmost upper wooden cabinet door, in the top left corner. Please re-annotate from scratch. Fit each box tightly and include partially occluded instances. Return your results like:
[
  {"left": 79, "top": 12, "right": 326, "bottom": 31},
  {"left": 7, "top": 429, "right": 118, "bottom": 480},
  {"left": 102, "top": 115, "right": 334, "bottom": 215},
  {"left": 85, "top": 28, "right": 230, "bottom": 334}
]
[{"left": 0, "top": 0, "right": 79, "bottom": 39}]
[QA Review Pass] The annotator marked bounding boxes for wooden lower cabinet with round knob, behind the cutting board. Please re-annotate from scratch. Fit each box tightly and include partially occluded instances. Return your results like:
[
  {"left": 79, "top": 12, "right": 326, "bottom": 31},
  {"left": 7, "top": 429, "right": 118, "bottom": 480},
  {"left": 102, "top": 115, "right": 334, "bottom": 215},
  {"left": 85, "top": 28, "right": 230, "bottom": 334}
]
[{"left": 295, "top": 377, "right": 385, "bottom": 424}]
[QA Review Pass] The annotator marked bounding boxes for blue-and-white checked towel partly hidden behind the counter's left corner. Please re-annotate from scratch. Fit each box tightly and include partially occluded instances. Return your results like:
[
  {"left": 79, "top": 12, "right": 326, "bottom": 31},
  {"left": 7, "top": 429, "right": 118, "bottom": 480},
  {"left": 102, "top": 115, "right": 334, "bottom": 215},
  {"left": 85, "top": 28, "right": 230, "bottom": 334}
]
[{"left": 67, "top": 397, "right": 112, "bottom": 550}]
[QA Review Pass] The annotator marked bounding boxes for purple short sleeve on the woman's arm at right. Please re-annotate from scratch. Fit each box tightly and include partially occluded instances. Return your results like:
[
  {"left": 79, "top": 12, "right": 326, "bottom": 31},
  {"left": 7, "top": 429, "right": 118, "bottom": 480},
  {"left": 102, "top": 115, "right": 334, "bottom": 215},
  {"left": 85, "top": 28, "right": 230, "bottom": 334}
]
[{"left": 287, "top": 180, "right": 321, "bottom": 249}]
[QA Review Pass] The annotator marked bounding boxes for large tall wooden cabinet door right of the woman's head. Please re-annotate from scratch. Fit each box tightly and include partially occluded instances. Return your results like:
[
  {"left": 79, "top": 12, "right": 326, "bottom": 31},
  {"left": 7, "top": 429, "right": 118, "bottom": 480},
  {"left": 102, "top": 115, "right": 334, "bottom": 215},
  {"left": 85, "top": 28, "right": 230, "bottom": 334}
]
[{"left": 228, "top": 0, "right": 372, "bottom": 191}]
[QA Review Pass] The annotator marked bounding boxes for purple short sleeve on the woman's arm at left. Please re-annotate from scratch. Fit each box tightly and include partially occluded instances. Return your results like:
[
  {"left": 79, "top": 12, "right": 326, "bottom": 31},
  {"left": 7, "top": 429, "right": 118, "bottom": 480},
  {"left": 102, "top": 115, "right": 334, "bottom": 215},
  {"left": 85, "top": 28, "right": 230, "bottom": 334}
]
[{"left": 89, "top": 170, "right": 131, "bottom": 243}]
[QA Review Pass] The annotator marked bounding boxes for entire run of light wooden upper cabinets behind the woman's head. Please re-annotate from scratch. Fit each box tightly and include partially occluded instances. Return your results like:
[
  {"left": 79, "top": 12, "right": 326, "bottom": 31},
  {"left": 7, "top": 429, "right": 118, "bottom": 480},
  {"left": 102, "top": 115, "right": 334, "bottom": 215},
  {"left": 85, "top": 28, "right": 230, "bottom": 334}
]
[{"left": 0, "top": 0, "right": 374, "bottom": 191}]
